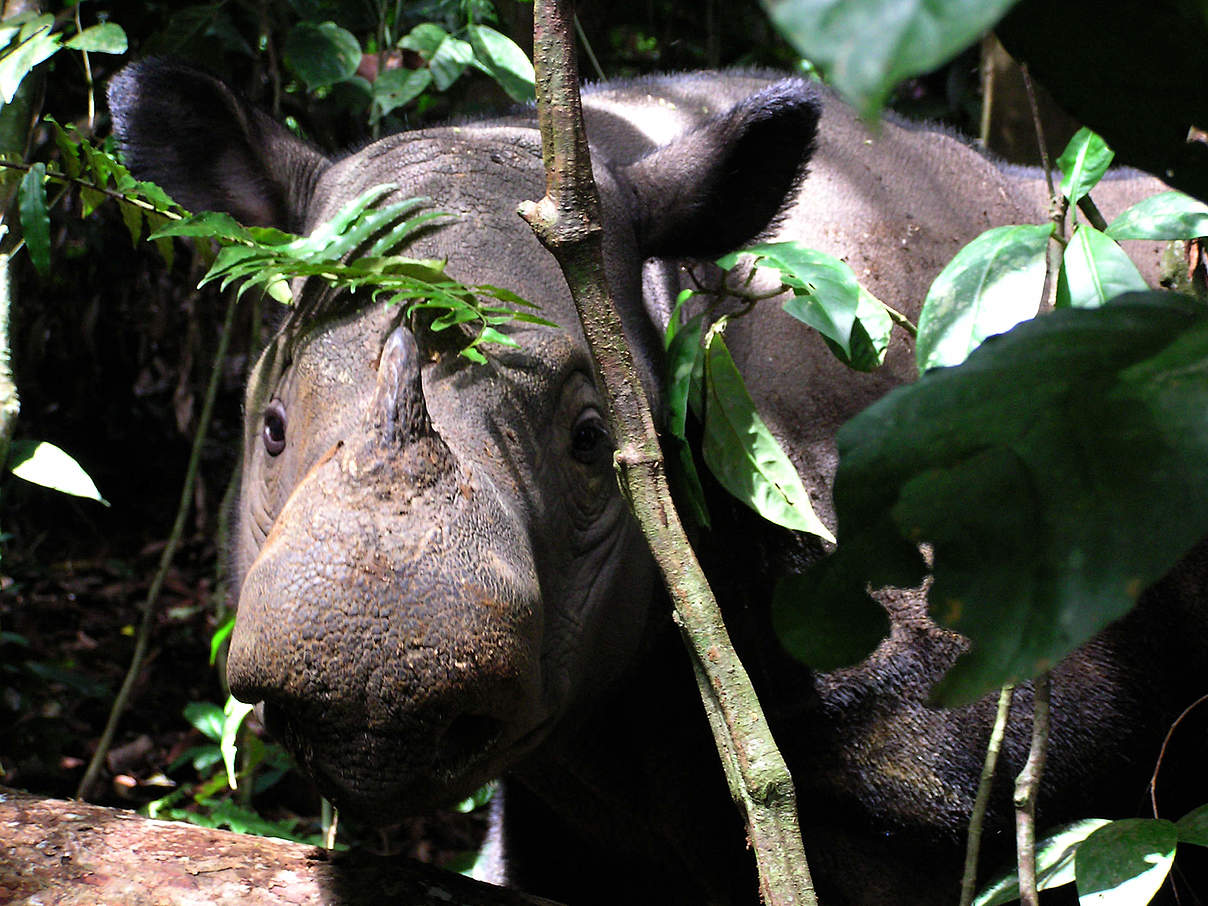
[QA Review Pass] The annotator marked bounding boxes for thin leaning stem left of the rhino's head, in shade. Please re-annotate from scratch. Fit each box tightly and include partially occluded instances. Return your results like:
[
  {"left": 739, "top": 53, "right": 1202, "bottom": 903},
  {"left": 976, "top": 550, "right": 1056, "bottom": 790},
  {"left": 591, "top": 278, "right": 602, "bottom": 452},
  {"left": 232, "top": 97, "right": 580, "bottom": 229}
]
[{"left": 76, "top": 290, "right": 238, "bottom": 798}]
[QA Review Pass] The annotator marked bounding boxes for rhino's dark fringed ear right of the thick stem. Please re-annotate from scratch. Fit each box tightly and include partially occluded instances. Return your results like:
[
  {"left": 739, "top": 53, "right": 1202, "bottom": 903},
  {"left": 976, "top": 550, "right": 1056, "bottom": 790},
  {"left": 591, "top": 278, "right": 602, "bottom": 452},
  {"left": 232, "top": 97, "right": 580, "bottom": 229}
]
[{"left": 625, "top": 79, "right": 821, "bottom": 257}]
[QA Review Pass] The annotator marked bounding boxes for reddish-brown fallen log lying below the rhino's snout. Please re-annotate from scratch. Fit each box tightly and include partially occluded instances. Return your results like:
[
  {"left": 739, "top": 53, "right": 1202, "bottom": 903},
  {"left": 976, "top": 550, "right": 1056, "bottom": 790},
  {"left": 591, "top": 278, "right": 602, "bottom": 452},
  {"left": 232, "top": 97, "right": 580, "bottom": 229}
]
[{"left": 0, "top": 788, "right": 556, "bottom": 906}]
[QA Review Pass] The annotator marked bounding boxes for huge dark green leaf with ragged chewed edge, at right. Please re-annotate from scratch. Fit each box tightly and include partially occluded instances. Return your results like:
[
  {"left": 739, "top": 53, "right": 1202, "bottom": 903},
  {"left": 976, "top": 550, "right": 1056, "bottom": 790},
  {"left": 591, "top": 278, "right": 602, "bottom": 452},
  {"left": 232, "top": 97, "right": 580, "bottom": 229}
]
[{"left": 802, "top": 292, "right": 1208, "bottom": 705}]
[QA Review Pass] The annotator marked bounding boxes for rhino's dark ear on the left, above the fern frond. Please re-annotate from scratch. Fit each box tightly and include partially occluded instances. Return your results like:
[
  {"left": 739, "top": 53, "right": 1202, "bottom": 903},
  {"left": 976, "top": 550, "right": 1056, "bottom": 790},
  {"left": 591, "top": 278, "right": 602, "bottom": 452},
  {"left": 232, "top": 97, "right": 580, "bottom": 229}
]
[{"left": 109, "top": 59, "right": 327, "bottom": 232}]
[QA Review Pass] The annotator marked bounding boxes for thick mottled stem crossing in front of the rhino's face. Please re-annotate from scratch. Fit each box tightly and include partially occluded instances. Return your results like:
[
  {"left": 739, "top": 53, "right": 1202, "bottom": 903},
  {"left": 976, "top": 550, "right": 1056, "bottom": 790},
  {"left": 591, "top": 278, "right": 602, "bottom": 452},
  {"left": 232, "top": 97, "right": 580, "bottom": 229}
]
[{"left": 519, "top": 0, "right": 817, "bottom": 906}]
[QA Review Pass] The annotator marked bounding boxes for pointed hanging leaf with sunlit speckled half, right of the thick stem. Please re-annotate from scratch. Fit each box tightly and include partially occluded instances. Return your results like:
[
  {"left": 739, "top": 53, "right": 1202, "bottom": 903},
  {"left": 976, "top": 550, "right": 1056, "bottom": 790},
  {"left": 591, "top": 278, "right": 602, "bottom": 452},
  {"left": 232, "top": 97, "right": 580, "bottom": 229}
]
[{"left": 702, "top": 332, "right": 835, "bottom": 541}]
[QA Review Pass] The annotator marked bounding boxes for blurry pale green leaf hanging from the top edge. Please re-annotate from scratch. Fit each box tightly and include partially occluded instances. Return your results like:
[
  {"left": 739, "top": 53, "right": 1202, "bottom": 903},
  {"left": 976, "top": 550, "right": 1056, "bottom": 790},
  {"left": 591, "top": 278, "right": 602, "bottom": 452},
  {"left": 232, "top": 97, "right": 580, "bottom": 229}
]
[{"left": 762, "top": 0, "right": 1015, "bottom": 118}]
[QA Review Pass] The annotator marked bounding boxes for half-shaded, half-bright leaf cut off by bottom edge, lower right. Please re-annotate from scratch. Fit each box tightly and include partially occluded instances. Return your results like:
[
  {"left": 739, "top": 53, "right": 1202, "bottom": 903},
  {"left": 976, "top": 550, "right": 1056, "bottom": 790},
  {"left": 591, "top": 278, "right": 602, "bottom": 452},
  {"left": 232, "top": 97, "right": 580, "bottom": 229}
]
[{"left": 1074, "top": 818, "right": 1178, "bottom": 906}]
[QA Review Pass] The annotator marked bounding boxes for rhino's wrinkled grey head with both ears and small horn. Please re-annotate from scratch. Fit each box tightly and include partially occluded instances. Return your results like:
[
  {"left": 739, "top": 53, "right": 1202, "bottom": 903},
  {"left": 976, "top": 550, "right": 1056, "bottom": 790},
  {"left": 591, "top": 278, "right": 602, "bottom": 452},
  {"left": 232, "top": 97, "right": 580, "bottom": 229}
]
[{"left": 109, "top": 60, "right": 819, "bottom": 823}]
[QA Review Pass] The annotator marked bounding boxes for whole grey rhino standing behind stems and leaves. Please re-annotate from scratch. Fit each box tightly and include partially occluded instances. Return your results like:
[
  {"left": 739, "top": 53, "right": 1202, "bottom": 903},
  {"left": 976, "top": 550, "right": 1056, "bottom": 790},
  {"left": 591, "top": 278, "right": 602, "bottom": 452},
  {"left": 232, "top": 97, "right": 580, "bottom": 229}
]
[{"left": 109, "top": 62, "right": 1206, "bottom": 906}]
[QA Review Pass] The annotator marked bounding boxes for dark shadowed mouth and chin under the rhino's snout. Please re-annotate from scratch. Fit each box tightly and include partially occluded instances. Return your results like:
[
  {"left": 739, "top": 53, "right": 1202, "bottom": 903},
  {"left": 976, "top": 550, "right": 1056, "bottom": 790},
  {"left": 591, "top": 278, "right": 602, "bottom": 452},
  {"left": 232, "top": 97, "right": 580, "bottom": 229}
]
[{"left": 262, "top": 703, "right": 526, "bottom": 826}]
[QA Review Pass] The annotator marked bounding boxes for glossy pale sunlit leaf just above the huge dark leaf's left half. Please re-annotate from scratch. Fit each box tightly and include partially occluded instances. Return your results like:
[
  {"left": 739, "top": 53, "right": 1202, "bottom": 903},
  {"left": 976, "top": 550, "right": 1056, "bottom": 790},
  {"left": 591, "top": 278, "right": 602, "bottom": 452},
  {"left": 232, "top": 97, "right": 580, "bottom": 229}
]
[{"left": 914, "top": 225, "right": 1052, "bottom": 372}]
